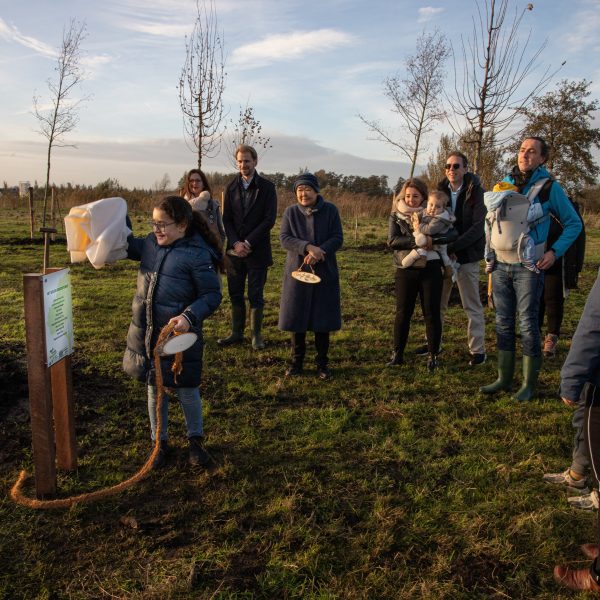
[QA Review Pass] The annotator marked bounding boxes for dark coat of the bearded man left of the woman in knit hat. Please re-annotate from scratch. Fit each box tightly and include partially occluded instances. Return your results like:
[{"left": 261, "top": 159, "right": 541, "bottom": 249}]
[{"left": 223, "top": 173, "right": 277, "bottom": 269}]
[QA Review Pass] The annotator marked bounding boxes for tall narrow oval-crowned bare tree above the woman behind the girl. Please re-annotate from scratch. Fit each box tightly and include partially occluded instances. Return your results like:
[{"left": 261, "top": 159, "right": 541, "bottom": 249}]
[{"left": 179, "top": 0, "right": 226, "bottom": 169}]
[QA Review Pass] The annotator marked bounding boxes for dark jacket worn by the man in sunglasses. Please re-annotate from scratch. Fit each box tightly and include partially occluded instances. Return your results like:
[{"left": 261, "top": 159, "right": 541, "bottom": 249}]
[{"left": 438, "top": 173, "right": 486, "bottom": 265}]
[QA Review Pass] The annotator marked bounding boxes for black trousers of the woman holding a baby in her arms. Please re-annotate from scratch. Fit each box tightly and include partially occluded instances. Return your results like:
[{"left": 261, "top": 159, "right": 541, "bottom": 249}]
[{"left": 394, "top": 260, "right": 444, "bottom": 356}]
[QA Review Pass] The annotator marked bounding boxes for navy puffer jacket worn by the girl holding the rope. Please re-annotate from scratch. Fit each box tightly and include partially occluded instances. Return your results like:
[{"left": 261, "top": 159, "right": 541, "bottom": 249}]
[{"left": 123, "top": 233, "right": 221, "bottom": 387}]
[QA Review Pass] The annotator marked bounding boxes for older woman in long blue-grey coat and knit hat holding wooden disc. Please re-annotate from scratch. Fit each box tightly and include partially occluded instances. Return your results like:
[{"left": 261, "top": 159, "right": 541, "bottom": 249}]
[{"left": 279, "top": 173, "right": 344, "bottom": 379}]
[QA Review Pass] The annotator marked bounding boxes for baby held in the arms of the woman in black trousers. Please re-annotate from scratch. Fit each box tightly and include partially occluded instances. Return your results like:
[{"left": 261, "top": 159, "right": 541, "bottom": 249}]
[{"left": 402, "top": 190, "right": 457, "bottom": 277}]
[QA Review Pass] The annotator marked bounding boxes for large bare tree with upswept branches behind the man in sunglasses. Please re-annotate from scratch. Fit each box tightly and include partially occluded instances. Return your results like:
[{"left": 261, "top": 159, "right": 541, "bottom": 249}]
[{"left": 448, "top": 0, "right": 564, "bottom": 173}]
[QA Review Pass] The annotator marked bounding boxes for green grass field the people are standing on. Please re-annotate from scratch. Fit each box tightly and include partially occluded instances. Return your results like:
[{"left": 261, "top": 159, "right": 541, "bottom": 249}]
[{"left": 0, "top": 210, "right": 600, "bottom": 600}]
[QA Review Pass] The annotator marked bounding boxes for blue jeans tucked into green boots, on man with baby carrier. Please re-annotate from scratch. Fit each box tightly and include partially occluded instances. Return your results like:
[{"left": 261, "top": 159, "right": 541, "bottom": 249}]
[{"left": 492, "top": 262, "right": 544, "bottom": 356}]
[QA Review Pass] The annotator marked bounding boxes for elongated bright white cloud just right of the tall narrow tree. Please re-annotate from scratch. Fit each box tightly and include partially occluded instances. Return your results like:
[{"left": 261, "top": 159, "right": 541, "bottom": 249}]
[{"left": 231, "top": 29, "right": 355, "bottom": 66}]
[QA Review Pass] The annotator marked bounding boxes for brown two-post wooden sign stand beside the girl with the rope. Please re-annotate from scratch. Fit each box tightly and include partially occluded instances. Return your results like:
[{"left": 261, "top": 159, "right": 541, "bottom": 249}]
[{"left": 23, "top": 269, "right": 77, "bottom": 497}]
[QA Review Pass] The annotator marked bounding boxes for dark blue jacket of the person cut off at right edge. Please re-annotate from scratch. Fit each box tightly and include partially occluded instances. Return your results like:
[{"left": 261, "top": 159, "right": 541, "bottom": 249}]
[{"left": 560, "top": 275, "right": 600, "bottom": 402}]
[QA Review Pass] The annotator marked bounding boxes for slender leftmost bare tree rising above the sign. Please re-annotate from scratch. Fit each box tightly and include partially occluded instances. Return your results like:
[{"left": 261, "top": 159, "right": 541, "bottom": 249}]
[{"left": 33, "top": 19, "right": 87, "bottom": 227}]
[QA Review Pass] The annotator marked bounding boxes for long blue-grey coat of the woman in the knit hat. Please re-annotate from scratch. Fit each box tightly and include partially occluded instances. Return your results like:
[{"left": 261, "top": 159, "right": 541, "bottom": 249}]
[{"left": 279, "top": 196, "right": 344, "bottom": 332}]
